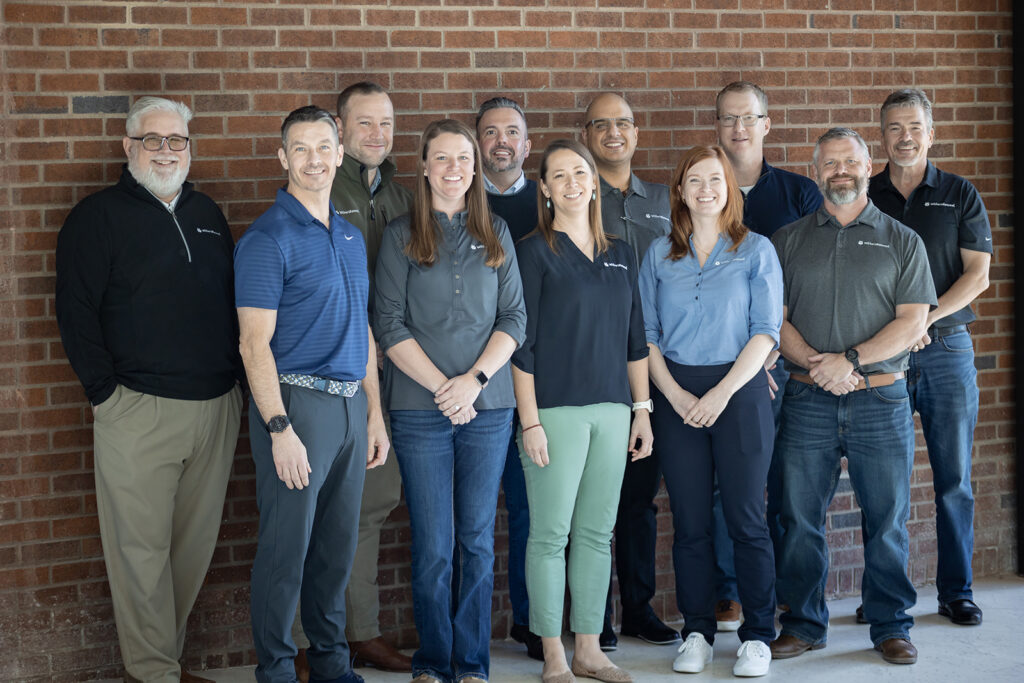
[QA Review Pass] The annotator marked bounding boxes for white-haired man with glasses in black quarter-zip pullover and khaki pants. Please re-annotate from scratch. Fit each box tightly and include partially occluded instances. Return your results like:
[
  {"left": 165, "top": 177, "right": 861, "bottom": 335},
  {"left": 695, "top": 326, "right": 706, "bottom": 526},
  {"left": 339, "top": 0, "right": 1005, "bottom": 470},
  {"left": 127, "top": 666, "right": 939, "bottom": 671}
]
[{"left": 56, "top": 97, "right": 242, "bottom": 683}]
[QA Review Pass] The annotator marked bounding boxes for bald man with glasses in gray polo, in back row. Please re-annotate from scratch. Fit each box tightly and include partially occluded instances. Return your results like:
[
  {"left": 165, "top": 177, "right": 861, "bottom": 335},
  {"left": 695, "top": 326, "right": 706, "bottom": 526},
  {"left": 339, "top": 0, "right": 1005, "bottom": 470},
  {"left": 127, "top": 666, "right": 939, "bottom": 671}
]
[{"left": 582, "top": 92, "right": 679, "bottom": 650}]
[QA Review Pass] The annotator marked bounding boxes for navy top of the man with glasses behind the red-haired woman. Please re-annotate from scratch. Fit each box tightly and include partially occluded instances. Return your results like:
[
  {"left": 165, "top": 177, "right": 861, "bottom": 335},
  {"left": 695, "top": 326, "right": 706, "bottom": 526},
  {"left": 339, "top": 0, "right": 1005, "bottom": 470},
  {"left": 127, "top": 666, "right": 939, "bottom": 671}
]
[{"left": 743, "top": 160, "right": 823, "bottom": 238}]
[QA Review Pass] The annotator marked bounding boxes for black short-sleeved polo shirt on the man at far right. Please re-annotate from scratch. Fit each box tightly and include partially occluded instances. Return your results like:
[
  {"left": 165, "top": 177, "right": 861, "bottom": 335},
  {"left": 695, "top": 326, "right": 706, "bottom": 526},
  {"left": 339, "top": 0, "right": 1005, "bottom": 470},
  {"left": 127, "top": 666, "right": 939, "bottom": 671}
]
[{"left": 867, "top": 162, "right": 992, "bottom": 328}]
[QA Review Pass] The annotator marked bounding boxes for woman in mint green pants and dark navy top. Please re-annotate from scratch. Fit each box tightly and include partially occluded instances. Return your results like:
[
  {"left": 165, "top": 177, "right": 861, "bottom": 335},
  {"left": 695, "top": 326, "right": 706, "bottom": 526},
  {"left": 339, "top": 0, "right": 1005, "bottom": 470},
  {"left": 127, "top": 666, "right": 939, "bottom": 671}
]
[{"left": 512, "top": 140, "right": 653, "bottom": 683}]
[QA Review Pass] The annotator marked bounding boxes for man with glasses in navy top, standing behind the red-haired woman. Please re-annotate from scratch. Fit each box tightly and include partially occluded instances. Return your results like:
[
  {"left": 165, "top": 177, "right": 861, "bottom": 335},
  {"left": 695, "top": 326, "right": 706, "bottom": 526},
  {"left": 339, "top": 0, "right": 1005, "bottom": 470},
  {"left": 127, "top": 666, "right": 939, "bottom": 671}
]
[{"left": 714, "top": 81, "right": 821, "bottom": 631}]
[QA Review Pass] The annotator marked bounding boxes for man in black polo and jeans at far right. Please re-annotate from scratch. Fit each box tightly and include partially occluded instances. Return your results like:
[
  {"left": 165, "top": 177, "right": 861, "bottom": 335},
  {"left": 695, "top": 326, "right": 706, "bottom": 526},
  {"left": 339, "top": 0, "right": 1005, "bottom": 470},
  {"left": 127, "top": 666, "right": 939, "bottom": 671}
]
[{"left": 867, "top": 89, "right": 992, "bottom": 626}]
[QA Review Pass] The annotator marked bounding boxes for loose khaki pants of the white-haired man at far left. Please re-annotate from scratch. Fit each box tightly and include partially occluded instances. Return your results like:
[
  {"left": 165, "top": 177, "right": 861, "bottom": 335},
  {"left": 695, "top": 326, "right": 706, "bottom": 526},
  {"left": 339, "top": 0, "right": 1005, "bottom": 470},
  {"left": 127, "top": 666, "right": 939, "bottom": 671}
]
[{"left": 93, "top": 385, "right": 242, "bottom": 683}]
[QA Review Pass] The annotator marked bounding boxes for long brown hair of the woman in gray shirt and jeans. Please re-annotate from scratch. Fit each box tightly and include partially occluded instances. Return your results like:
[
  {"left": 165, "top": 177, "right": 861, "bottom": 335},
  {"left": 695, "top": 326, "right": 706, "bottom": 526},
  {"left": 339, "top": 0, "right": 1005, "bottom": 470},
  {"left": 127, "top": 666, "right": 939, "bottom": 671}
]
[{"left": 406, "top": 119, "right": 505, "bottom": 268}]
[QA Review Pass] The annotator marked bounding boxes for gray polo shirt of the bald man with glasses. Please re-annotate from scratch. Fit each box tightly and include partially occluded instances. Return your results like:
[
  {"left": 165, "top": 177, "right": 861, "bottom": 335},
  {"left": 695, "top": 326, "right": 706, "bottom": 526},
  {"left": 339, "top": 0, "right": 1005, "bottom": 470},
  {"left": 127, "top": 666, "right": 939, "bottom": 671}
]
[{"left": 601, "top": 173, "right": 672, "bottom": 264}]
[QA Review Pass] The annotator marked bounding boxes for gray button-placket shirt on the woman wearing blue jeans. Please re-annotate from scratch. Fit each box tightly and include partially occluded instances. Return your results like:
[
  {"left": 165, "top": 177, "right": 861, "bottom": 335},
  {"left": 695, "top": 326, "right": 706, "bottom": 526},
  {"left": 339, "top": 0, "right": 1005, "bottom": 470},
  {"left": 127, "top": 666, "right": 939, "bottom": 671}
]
[{"left": 374, "top": 211, "right": 526, "bottom": 411}]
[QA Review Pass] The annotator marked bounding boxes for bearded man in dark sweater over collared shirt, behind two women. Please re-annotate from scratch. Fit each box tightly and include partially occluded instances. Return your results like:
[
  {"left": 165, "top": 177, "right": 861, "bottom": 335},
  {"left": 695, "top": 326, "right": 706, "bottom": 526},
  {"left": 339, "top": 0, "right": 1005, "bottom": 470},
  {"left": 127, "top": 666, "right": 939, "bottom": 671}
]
[{"left": 476, "top": 97, "right": 544, "bottom": 661}]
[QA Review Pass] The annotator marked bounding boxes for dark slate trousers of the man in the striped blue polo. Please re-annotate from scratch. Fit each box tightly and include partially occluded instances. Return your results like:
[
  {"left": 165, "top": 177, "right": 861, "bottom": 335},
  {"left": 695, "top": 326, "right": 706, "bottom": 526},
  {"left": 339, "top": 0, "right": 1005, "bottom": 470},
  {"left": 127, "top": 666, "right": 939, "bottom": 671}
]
[{"left": 249, "top": 384, "right": 367, "bottom": 683}]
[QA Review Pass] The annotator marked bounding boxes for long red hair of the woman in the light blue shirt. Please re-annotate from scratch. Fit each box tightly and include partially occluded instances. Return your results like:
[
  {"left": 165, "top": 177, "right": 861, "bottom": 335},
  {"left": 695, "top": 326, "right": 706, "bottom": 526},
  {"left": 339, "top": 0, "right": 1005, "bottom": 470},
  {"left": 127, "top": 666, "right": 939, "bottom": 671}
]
[{"left": 669, "top": 144, "right": 748, "bottom": 261}]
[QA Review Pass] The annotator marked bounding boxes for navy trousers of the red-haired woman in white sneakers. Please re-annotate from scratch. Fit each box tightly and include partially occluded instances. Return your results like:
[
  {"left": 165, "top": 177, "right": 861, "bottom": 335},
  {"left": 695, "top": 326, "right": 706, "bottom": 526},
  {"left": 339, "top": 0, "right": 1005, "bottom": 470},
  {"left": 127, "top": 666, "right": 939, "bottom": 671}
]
[{"left": 651, "top": 358, "right": 775, "bottom": 643}]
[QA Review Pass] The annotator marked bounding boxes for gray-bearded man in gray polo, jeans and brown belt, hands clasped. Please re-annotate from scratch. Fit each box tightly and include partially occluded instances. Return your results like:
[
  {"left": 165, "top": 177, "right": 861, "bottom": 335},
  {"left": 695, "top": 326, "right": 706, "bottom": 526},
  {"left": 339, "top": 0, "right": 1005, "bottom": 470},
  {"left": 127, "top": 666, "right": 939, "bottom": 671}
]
[{"left": 771, "top": 128, "right": 936, "bottom": 664}]
